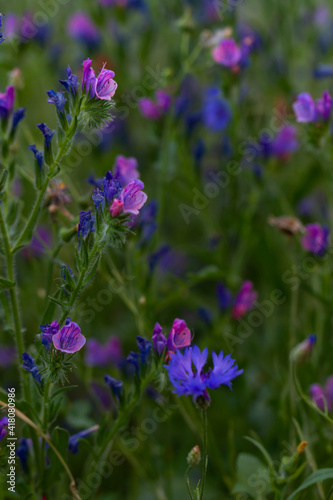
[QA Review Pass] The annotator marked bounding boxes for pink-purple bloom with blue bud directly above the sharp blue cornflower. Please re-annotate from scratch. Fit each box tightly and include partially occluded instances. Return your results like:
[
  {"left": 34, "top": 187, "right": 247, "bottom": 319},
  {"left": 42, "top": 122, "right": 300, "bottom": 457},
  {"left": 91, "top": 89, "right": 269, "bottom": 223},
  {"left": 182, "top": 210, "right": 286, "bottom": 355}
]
[{"left": 152, "top": 318, "right": 192, "bottom": 360}]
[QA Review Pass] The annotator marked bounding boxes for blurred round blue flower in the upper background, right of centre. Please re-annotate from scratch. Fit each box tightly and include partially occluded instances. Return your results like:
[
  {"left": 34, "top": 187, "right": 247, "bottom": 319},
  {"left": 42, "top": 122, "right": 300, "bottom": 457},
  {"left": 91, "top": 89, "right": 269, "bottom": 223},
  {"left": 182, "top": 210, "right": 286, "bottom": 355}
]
[{"left": 203, "top": 87, "right": 231, "bottom": 132}]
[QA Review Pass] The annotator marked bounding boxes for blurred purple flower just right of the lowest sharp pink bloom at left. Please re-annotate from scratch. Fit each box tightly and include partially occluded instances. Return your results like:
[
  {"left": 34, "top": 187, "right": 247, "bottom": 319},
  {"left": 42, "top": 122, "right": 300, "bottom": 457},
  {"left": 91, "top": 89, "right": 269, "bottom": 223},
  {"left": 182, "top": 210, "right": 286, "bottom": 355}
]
[{"left": 85, "top": 336, "right": 122, "bottom": 366}]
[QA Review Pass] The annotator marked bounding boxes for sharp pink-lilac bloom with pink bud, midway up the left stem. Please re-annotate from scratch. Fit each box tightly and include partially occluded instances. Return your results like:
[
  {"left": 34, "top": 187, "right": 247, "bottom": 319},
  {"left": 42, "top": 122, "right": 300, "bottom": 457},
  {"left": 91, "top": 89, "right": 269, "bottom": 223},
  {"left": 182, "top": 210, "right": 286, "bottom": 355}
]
[{"left": 110, "top": 179, "right": 148, "bottom": 217}]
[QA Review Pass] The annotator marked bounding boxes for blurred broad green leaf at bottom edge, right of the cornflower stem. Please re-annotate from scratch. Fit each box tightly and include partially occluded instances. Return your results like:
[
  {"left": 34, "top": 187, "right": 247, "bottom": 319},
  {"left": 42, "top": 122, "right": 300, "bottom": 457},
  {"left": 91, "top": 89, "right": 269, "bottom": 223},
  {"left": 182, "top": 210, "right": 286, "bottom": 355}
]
[{"left": 232, "top": 453, "right": 272, "bottom": 500}]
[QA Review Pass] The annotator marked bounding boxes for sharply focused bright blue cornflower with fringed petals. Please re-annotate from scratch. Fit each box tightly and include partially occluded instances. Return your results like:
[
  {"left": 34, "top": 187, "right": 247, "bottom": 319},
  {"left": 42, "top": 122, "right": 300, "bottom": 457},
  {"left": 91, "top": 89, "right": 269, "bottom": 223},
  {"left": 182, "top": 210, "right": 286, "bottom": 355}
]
[{"left": 164, "top": 346, "right": 243, "bottom": 401}]
